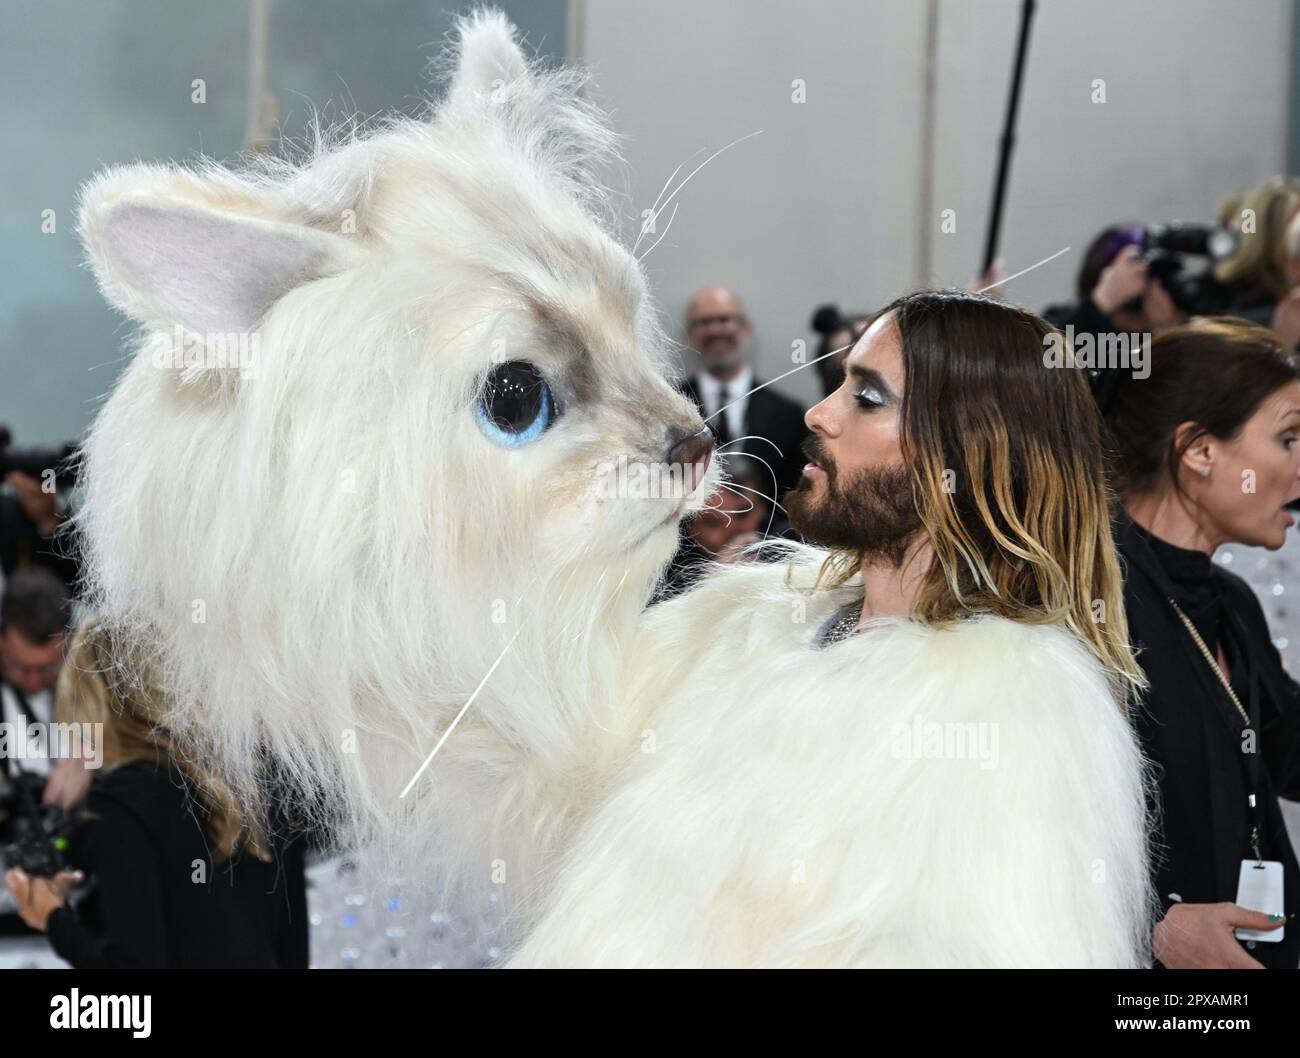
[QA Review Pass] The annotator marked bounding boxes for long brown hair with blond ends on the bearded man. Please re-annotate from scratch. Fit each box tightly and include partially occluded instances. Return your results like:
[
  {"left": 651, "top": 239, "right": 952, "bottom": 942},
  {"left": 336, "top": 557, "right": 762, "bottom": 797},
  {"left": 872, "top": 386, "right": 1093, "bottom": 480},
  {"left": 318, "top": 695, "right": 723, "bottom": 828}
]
[{"left": 823, "top": 291, "right": 1144, "bottom": 703}]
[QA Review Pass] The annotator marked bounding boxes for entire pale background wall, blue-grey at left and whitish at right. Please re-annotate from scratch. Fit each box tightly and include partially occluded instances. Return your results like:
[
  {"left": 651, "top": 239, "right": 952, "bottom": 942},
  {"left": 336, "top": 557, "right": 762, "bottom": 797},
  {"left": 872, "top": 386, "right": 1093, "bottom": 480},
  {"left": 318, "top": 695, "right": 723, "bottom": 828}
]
[{"left": 0, "top": 0, "right": 1294, "bottom": 445}]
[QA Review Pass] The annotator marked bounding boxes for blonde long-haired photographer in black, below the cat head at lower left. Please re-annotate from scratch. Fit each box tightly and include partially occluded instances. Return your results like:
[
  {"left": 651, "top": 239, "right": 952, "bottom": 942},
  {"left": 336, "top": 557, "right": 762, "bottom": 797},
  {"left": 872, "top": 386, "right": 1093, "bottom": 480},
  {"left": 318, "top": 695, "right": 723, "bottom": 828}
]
[{"left": 5, "top": 621, "right": 307, "bottom": 970}]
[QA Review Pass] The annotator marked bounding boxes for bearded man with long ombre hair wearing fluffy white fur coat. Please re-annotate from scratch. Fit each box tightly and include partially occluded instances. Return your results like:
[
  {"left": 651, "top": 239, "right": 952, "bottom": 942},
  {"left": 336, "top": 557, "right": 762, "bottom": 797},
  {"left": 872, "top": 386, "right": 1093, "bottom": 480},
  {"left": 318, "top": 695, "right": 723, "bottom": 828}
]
[{"left": 501, "top": 292, "right": 1152, "bottom": 966}]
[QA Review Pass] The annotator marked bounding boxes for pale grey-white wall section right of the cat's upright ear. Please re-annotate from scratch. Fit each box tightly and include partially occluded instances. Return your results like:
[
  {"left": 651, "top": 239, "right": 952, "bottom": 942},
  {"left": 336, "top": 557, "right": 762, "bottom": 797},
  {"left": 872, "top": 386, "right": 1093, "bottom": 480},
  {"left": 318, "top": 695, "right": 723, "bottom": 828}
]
[{"left": 585, "top": 0, "right": 1292, "bottom": 410}]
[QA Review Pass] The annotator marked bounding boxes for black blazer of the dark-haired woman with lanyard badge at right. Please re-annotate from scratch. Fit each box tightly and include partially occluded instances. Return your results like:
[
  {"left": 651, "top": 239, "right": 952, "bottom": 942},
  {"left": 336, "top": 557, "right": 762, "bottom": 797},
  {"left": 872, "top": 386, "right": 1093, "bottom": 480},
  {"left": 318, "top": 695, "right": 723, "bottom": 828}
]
[{"left": 1115, "top": 515, "right": 1300, "bottom": 970}]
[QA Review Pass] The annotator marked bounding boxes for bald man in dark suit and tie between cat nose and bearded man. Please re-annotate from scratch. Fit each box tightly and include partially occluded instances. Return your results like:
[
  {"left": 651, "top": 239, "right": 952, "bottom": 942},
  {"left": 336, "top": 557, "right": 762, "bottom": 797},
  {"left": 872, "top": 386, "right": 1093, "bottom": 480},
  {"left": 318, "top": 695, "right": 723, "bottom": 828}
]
[{"left": 680, "top": 286, "right": 807, "bottom": 509}]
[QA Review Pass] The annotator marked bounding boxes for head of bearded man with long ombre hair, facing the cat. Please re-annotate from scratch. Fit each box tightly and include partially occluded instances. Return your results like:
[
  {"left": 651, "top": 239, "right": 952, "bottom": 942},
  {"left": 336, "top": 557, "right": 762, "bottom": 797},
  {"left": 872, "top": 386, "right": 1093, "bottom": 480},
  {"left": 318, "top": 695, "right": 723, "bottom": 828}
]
[{"left": 787, "top": 291, "right": 1140, "bottom": 698}]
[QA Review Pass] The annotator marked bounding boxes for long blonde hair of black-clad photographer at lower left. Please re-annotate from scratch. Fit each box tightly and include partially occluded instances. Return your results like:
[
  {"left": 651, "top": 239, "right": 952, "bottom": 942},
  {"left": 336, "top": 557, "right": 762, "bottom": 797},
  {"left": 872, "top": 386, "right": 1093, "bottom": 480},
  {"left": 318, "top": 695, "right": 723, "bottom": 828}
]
[{"left": 55, "top": 617, "right": 270, "bottom": 860}]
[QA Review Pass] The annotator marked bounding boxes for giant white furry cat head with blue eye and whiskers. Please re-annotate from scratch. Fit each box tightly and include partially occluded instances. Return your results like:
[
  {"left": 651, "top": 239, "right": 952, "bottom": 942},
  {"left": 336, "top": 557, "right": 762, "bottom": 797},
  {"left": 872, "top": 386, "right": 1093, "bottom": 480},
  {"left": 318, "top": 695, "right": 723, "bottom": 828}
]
[{"left": 81, "top": 6, "right": 716, "bottom": 852}]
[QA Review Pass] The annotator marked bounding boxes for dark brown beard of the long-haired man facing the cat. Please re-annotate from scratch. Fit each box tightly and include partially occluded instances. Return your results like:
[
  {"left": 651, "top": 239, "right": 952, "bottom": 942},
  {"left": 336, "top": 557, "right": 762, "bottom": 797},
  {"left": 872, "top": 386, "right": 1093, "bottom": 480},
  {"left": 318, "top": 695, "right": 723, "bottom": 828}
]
[{"left": 785, "top": 437, "right": 922, "bottom": 565}]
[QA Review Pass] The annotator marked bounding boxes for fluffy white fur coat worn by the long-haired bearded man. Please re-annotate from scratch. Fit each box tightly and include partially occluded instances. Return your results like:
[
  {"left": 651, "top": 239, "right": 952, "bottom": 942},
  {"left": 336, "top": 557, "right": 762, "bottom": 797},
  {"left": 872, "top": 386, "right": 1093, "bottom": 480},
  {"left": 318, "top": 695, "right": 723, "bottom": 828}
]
[{"left": 514, "top": 563, "right": 1149, "bottom": 967}]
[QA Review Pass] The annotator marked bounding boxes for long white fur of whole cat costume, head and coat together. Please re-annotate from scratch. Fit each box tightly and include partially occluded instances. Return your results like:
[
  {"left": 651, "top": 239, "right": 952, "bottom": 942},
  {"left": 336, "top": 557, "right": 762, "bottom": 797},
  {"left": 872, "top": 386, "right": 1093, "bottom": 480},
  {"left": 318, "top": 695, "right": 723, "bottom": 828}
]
[{"left": 73, "top": 13, "right": 1145, "bottom": 964}]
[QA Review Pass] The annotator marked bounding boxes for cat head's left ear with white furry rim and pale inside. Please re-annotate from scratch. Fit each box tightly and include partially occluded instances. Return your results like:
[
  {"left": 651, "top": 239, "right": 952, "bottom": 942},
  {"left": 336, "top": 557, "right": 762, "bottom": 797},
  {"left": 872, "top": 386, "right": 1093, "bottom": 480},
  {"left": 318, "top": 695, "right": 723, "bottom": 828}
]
[{"left": 79, "top": 165, "right": 355, "bottom": 335}]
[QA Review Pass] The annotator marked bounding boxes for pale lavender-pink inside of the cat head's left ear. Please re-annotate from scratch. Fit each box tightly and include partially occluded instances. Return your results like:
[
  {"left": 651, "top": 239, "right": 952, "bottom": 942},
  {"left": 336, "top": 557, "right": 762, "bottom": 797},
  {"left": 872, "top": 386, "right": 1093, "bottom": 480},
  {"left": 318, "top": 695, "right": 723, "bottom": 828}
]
[{"left": 101, "top": 201, "right": 335, "bottom": 334}]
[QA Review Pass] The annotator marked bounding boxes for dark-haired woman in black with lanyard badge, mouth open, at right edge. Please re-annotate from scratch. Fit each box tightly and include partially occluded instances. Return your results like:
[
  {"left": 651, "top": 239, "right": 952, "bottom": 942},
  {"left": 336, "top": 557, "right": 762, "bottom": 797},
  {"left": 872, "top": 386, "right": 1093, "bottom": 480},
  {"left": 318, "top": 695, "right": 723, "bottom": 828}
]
[{"left": 1108, "top": 317, "right": 1300, "bottom": 968}]
